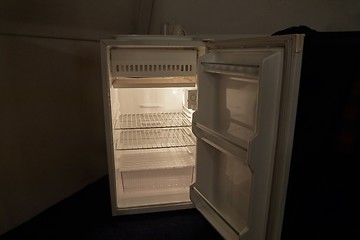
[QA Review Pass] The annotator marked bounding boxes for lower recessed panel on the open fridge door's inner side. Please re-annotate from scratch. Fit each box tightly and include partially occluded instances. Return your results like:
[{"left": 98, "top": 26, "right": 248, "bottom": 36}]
[{"left": 196, "top": 141, "right": 253, "bottom": 233}]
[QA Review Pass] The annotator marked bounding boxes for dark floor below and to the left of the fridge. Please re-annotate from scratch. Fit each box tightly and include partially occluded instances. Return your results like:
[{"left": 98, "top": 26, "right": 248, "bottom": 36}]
[{"left": 0, "top": 176, "right": 223, "bottom": 240}]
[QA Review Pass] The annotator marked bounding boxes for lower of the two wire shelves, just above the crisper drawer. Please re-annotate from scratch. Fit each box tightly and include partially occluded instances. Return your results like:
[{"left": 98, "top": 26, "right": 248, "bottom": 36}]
[{"left": 116, "top": 127, "right": 195, "bottom": 150}]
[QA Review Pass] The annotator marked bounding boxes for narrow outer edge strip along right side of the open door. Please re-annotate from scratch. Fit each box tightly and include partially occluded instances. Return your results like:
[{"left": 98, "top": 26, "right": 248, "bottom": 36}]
[{"left": 266, "top": 35, "right": 303, "bottom": 240}]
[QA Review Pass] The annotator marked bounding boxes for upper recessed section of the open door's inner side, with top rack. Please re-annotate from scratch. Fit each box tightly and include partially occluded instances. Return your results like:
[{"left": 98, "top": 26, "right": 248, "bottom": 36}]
[{"left": 197, "top": 54, "right": 264, "bottom": 146}]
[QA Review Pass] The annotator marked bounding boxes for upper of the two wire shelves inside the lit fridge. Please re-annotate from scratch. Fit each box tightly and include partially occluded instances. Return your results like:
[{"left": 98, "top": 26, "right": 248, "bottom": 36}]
[{"left": 115, "top": 112, "right": 191, "bottom": 129}]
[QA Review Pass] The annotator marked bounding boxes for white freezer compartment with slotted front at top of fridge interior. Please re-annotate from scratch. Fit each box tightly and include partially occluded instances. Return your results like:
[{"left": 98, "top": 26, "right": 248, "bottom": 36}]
[{"left": 109, "top": 47, "right": 197, "bottom": 88}]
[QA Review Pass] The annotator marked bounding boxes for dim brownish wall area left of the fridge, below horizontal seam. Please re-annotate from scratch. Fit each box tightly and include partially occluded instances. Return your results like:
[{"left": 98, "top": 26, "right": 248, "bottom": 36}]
[{"left": 0, "top": 36, "right": 107, "bottom": 234}]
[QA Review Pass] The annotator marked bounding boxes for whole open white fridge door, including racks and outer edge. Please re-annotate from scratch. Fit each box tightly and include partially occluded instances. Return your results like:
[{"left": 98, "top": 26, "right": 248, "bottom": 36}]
[{"left": 190, "top": 36, "right": 301, "bottom": 240}]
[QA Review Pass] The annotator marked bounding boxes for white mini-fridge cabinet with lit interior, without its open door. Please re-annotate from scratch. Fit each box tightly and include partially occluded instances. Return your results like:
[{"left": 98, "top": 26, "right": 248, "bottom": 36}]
[{"left": 103, "top": 41, "right": 205, "bottom": 214}]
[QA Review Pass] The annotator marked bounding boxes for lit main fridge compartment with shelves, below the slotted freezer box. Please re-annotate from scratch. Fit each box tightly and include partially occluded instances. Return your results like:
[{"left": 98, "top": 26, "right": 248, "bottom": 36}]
[{"left": 110, "top": 88, "right": 196, "bottom": 209}]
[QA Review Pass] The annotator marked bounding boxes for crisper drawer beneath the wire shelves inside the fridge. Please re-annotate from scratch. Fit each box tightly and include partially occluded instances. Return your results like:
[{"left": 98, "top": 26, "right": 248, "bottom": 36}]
[{"left": 118, "top": 148, "right": 194, "bottom": 192}]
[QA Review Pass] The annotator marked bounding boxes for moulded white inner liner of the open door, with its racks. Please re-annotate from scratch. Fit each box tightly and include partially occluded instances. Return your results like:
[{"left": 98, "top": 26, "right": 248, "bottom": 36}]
[{"left": 190, "top": 48, "right": 284, "bottom": 239}]
